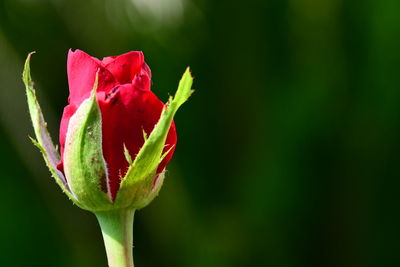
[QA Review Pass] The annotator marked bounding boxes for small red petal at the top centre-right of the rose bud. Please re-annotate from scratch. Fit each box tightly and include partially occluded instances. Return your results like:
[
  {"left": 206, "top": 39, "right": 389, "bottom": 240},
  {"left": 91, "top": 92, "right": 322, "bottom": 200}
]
[{"left": 102, "top": 51, "right": 144, "bottom": 84}]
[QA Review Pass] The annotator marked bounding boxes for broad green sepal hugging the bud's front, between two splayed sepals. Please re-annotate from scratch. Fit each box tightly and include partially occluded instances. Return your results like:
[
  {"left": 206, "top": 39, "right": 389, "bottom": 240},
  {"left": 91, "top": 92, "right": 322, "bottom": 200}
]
[{"left": 64, "top": 74, "right": 113, "bottom": 211}]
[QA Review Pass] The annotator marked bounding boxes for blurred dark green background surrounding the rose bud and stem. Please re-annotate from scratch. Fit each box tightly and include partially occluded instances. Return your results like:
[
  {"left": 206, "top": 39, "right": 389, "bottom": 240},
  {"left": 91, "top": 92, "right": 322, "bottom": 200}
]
[{"left": 0, "top": 0, "right": 400, "bottom": 267}]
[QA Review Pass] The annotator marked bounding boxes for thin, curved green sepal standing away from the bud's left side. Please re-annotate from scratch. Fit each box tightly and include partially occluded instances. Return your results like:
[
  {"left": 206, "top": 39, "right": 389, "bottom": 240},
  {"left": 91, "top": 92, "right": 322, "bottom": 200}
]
[{"left": 22, "top": 52, "right": 82, "bottom": 207}]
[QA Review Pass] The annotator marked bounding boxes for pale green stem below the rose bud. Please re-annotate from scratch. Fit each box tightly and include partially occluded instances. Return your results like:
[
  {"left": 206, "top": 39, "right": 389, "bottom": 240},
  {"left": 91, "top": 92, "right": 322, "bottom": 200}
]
[{"left": 96, "top": 210, "right": 135, "bottom": 267}]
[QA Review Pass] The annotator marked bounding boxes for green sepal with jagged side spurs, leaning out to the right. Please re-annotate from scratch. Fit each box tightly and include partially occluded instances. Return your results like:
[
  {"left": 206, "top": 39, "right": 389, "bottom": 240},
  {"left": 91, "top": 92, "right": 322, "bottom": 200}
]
[{"left": 114, "top": 68, "right": 193, "bottom": 209}]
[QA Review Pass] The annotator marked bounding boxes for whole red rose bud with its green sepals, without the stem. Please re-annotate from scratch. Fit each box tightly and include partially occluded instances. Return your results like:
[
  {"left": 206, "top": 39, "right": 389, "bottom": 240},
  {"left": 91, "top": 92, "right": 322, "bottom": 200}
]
[{"left": 23, "top": 50, "right": 193, "bottom": 211}]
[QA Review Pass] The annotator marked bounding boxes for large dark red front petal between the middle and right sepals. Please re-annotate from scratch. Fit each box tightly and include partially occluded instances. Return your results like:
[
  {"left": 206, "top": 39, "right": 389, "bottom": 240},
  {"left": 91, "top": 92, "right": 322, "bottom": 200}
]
[{"left": 97, "top": 84, "right": 176, "bottom": 199}]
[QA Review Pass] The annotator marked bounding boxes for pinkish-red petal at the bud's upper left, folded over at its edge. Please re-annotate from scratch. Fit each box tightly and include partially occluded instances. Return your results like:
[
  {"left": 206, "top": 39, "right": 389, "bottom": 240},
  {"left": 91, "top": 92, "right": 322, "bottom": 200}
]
[{"left": 67, "top": 50, "right": 116, "bottom": 106}]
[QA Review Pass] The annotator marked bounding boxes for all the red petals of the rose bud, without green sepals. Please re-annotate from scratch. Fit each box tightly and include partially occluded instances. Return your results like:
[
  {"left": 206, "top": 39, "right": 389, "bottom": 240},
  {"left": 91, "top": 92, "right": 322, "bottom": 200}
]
[{"left": 58, "top": 50, "right": 176, "bottom": 200}]
